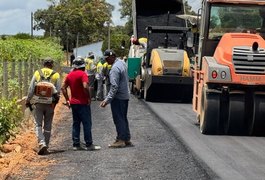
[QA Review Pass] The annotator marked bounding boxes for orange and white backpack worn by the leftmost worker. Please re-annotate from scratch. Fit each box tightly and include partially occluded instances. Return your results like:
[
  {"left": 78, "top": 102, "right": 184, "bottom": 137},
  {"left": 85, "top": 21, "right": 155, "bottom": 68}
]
[{"left": 32, "top": 70, "right": 57, "bottom": 104}]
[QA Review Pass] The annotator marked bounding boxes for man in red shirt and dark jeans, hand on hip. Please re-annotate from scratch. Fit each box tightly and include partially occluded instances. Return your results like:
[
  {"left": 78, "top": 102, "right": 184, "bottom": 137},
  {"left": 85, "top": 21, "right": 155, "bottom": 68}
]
[{"left": 62, "top": 57, "right": 100, "bottom": 151}]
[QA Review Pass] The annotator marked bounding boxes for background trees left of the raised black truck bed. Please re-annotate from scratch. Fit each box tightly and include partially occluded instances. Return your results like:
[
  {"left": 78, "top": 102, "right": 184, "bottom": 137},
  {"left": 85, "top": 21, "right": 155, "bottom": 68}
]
[{"left": 34, "top": 0, "right": 133, "bottom": 56}]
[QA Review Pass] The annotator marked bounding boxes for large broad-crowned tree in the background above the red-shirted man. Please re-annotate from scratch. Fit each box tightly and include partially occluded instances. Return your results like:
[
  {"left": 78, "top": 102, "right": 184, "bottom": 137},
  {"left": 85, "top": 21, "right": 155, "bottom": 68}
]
[{"left": 34, "top": 0, "right": 114, "bottom": 50}]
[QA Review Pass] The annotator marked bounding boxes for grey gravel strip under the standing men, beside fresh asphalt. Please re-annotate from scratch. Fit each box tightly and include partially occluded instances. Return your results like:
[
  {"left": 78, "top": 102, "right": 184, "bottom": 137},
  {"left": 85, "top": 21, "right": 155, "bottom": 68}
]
[{"left": 10, "top": 96, "right": 215, "bottom": 180}]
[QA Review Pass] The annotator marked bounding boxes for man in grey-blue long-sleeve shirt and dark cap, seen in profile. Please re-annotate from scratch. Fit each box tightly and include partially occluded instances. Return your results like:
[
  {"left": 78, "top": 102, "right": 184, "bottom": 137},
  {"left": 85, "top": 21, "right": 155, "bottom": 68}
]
[{"left": 100, "top": 50, "right": 132, "bottom": 148}]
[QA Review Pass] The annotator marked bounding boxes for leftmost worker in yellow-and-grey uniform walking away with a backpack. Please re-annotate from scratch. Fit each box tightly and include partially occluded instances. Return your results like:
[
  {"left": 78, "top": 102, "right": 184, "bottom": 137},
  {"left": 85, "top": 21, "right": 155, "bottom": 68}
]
[{"left": 26, "top": 58, "right": 61, "bottom": 155}]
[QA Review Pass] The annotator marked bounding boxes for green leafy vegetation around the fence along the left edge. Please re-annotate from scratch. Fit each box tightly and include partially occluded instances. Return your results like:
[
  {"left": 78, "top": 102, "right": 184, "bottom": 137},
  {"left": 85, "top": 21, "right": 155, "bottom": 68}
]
[{"left": 0, "top": 38, "right": 64, "bottom": 144}]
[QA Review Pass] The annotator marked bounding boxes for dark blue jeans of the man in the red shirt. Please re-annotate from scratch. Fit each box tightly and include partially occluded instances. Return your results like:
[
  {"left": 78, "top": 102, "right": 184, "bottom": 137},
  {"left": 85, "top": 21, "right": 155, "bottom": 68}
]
[{"left": 71, "top": 104, "right": 93, "bottom": 147}]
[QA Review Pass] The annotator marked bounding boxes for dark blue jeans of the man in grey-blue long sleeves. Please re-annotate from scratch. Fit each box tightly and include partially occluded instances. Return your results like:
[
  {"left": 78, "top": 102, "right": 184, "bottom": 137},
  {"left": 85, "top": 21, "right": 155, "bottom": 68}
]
[{"left": 110, "top": 98, "right": 131, "bottom": 141}]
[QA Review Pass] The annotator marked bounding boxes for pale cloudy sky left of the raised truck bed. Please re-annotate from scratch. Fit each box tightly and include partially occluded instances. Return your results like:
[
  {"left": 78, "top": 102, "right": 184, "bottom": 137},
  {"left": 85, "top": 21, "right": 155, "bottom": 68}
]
[{"left": 0, "top": 0, "right": 125, "bottom": 35}]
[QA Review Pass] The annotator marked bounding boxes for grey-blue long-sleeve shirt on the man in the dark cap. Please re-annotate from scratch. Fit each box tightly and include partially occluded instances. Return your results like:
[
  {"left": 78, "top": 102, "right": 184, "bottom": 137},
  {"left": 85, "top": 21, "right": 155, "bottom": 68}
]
[{"left": 105, "top": 59, "right": 129, "bottom": 103}]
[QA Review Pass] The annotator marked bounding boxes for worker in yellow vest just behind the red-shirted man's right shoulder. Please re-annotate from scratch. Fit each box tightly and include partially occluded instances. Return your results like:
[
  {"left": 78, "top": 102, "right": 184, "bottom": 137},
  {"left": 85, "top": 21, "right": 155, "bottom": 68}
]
[{"left": 85, "top": 52, "right": 96, "bottom": 100}]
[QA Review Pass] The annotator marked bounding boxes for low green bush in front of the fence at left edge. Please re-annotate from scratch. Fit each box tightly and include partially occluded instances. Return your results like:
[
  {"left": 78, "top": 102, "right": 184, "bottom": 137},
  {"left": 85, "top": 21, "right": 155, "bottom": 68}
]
[{"left": 0, "top": 99, "right": 23, "bottom": 144}]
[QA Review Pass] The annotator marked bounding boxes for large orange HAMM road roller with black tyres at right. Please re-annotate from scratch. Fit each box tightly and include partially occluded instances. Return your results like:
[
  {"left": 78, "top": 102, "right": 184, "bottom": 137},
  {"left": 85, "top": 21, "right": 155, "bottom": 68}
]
[{"left": 193, "top": 0, "right": 265, "bottom": 136}]
